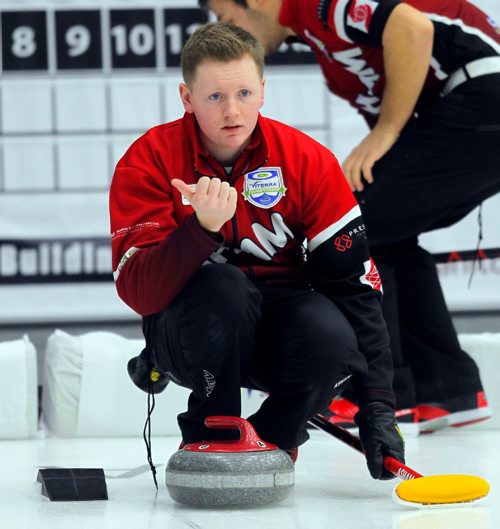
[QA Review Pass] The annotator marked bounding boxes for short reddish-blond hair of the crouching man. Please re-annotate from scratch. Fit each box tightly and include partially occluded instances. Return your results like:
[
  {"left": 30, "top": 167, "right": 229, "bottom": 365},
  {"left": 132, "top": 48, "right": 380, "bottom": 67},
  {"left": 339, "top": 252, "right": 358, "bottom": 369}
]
[{"left": 181, "top": 22, "right": 265, "bottom": 86}]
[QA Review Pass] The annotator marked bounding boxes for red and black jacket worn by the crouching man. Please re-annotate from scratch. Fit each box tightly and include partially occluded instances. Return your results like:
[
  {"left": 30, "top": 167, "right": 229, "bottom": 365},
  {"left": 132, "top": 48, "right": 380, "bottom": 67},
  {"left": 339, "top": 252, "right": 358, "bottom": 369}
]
[{"left": 110, "top": 114, "right": 392, "bottom": 400}]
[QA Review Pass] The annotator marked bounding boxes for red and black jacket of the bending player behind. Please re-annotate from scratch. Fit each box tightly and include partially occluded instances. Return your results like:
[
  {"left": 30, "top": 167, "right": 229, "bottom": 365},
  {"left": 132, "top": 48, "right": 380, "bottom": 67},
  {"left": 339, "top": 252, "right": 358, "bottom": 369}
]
[{"left": 280, "top": 0, "right": 500, "bottom": 126}]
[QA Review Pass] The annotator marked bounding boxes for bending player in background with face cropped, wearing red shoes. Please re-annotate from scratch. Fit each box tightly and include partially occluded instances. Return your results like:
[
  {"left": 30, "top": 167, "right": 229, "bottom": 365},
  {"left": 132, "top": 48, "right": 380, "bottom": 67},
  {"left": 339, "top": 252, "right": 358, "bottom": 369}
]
[{"left": 200, "top": 0, "right": 500, "bottom": 431}]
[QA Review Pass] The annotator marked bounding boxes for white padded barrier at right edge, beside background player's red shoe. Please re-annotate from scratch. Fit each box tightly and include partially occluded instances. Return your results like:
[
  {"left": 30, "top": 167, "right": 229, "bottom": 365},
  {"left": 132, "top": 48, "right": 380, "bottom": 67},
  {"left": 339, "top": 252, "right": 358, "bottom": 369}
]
[{"left": 458, "top": 332, "right": 500, "bottom": 430}]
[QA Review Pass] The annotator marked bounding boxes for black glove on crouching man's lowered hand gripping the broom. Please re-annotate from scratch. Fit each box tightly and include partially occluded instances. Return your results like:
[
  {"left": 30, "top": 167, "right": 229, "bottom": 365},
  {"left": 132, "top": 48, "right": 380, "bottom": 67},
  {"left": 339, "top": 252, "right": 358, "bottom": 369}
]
[{"left": 354, "top": 402, "right": 405, "bottom": 479}]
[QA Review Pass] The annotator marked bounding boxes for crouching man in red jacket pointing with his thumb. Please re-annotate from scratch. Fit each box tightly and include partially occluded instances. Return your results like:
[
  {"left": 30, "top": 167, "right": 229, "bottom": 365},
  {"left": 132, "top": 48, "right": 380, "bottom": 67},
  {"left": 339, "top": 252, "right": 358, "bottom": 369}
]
[{"left": 110, "top": 24, "right": 404, "bottom": 479}]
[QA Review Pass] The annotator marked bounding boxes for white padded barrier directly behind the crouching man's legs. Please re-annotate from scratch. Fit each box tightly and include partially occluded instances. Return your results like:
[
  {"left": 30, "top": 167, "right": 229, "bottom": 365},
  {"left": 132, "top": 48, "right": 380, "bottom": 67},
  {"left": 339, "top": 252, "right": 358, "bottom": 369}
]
[{"left": 42, "top": 330, "right": 270, "bottom": 437}]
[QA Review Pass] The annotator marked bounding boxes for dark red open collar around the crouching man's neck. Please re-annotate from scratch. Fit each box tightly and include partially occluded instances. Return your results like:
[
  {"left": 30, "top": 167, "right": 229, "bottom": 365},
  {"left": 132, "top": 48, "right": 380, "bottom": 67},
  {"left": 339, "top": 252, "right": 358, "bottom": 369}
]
[{"left": 182, "top": 112, "right": 269, "bottom": 177}]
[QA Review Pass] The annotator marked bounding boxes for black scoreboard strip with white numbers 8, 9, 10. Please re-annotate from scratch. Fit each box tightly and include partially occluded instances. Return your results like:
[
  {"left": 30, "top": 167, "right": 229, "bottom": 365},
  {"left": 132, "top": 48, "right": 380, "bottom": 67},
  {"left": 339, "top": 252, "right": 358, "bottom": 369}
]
[{"left": 0, "top": 8, "right": 314, "bottom": 74}]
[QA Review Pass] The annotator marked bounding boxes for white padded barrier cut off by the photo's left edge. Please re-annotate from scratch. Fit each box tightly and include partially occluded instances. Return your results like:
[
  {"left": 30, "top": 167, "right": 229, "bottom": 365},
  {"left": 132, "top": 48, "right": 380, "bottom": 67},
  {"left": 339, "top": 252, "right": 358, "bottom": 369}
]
[{"left": 0, "top": 336, "right": 38, "bottom": 439}]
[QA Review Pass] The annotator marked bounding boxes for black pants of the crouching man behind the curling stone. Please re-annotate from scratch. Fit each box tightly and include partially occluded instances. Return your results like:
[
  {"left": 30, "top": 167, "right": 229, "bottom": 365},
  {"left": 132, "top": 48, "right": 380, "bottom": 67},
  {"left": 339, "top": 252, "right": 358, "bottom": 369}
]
[{"left": 144, "top": 264, "right": 366, "bottom": 449}]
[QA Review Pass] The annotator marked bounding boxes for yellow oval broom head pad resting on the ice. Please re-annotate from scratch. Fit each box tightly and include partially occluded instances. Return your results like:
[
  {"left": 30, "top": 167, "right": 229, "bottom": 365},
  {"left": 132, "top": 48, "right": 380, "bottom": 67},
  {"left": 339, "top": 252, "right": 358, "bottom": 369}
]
[{"left": 394, "top": 474, "right": 490, "bottom": 505}]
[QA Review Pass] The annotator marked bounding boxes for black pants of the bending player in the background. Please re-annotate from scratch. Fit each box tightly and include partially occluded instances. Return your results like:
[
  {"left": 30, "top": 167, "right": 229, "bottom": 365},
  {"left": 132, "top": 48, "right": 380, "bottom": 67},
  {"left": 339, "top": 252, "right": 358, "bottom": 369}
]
[{"left": 358, "top": 74, "right": 500, "bottom": 408}]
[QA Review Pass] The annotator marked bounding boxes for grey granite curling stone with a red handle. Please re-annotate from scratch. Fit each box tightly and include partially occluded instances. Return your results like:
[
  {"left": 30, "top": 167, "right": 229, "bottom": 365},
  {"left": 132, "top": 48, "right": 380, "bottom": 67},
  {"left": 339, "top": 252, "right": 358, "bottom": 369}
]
[{"left": 165, "top": 416, "right": 295, "bottom": 507}]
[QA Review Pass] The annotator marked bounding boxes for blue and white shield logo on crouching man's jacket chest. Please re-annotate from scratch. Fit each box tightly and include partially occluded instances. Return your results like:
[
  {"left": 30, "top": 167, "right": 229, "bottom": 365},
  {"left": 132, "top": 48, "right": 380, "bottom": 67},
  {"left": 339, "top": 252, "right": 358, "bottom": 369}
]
[{"left": 242, "top": 167, "right": 286, "bottom": 209}]
